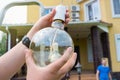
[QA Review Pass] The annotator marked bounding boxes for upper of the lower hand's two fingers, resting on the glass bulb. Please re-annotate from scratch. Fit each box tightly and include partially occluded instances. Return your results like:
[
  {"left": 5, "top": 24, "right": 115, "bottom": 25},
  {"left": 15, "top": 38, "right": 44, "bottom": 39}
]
[{"left": 48, "top": 47, "right": 73, "bottom": 72}]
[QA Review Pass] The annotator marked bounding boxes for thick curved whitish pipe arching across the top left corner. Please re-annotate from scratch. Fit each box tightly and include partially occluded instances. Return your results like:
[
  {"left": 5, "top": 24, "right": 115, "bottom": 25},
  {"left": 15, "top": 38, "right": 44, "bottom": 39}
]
[{"left": 0, "top": 0, "right": 44, "bottom": 25}]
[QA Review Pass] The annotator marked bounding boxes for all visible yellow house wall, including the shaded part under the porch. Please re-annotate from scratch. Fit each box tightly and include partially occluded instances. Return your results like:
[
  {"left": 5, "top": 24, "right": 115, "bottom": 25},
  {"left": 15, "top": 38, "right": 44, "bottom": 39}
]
[{"left": 28, "top": 0, "right": 120, "bottom": 72}]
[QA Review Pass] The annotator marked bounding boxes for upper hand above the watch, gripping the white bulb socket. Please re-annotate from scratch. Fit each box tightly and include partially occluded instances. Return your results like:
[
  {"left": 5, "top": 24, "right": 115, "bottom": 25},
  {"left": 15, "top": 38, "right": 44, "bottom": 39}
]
[{"left": 27, "top": 9, "right": 70, "bottom": 39}]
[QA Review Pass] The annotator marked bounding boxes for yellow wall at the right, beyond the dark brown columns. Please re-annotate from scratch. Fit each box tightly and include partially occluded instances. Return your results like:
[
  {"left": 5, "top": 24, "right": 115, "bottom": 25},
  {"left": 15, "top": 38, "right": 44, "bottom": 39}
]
[{"left": 100, "top": 0, "right": 120, "bottom": 72}]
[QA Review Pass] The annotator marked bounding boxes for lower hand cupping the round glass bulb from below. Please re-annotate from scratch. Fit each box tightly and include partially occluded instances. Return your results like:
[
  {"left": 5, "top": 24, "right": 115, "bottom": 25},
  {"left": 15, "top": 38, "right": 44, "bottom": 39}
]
[{"left": 25, "top": 48, "right": 76, "bottom": 80}]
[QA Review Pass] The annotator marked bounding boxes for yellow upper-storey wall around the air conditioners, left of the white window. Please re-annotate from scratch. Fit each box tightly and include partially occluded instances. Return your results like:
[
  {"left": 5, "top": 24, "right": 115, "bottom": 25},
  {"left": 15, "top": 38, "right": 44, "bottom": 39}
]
[{"left": 27, "top": 0, "right": 84, "bottom": 23}]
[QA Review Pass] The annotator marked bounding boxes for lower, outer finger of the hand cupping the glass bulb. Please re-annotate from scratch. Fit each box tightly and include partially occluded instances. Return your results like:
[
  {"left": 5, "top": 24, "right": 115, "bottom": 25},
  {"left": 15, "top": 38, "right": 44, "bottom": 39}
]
[{"left": 59, "top": 53, "right": 77, "bottom": 74}]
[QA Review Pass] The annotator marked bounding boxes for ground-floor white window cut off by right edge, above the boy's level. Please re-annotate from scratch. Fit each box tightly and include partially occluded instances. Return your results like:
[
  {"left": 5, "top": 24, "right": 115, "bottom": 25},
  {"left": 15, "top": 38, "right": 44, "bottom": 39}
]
[{"left": 115, "top": 34, "right": 120, "bottom": 61}]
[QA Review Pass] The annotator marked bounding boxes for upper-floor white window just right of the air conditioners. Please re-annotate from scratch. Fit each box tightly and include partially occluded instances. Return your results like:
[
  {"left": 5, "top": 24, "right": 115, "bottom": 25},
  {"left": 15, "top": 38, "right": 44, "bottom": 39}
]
[{"left": 85, "top": 0, "right": 100, "bottom": 21}]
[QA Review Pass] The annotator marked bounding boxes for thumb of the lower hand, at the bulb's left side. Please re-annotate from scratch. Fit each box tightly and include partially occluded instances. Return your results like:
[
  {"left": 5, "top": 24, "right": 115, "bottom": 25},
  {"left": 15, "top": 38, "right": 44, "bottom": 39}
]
[{"left": 25, "top": 49, "right": 35, "bottom": 68}]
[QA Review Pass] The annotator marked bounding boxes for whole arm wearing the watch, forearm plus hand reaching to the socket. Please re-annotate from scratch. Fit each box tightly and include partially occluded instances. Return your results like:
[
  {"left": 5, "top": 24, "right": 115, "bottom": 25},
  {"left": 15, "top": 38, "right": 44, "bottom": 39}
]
[{"left": 0, "top": 10, "right": 55, "bottom": 80}]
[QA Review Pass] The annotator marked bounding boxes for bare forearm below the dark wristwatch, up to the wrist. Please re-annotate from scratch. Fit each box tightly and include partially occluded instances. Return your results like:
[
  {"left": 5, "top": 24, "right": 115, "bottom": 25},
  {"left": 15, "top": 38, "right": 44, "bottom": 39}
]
[{"left": 0, "top": 42, "right": 27, "bottom": 80}]
